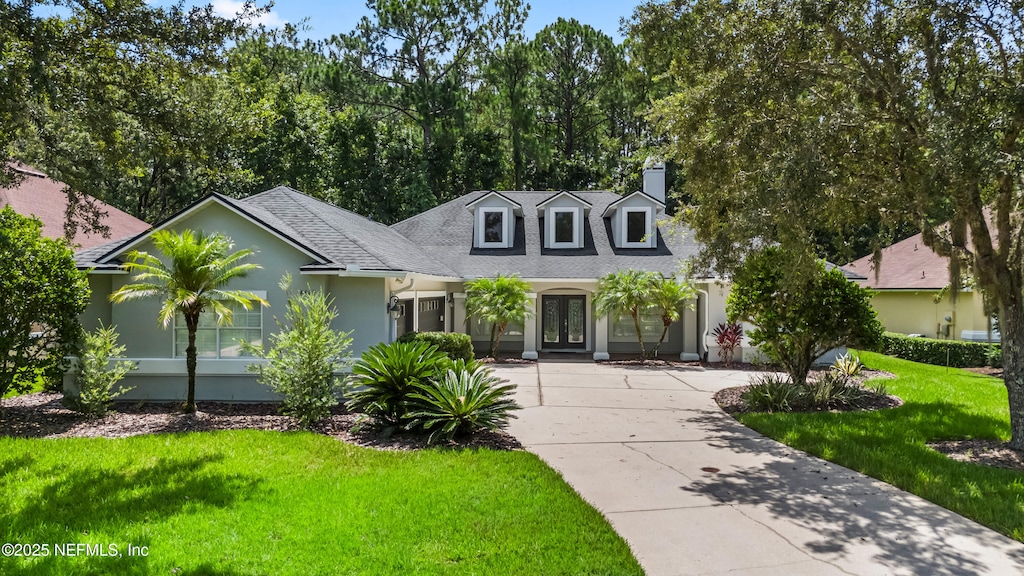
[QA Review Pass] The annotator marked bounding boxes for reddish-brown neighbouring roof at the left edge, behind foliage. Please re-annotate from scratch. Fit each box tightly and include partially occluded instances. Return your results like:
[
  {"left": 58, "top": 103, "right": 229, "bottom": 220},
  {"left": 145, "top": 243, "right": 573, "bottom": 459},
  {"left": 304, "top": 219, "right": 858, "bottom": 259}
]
[{"left": 0, "top": 164, "right": 150, "bottom": 249}]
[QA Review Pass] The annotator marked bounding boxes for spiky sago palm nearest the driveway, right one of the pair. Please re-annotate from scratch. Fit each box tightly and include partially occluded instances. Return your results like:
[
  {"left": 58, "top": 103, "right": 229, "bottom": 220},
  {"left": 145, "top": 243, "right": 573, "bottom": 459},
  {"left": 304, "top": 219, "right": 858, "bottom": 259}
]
[{"left": 406, "top": 361, "right": 520, "bottom": 443}]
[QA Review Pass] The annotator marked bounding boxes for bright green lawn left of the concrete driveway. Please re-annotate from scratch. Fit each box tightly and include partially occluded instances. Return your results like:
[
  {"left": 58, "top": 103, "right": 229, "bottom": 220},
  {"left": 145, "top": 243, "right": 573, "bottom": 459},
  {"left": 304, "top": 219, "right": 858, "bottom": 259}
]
[{"left": 0, "top": 430, "right": 642, "bottom": 576}]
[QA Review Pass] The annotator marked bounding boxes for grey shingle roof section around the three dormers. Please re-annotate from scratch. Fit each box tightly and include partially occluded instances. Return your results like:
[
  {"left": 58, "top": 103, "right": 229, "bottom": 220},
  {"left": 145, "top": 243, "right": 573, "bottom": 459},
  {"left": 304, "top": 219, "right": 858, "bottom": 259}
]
[{"left": 391, "top": 191, "right": 699, "bottom": 279}]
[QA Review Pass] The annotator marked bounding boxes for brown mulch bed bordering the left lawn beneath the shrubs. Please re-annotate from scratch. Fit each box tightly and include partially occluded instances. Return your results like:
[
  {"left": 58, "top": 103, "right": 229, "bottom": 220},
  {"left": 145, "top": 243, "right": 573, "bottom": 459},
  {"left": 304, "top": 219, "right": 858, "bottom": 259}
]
[{"left": 0, "top": 393, "right": 522, "bottom": 450}]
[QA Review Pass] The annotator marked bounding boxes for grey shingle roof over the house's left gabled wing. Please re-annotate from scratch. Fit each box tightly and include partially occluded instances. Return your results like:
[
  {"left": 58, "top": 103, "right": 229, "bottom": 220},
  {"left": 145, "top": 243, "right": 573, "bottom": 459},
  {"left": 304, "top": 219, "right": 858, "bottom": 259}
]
[{"left": 77, "top": 187, "right": 455, "bottom": 277}]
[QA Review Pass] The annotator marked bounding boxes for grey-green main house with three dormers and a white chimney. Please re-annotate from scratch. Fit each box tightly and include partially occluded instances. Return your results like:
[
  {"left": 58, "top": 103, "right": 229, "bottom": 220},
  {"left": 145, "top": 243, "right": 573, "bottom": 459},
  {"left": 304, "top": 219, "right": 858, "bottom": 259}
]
[{"left": 68, "top": 165, "right": 856, "bottom": 401}]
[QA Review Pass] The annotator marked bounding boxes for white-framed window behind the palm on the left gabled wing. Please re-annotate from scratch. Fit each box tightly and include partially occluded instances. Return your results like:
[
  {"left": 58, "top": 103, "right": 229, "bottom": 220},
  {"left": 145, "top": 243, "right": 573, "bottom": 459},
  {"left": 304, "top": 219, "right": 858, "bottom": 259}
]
[{"left": 174, "top": 291, "right": 266, "bottom": 358}]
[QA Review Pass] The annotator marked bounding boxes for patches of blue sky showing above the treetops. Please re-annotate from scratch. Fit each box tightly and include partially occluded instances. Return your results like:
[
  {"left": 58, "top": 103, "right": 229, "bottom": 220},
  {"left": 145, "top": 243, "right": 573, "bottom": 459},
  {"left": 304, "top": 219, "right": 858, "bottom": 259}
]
[{"left": 210, "top": 0, "right": 638, "bottom": 43}]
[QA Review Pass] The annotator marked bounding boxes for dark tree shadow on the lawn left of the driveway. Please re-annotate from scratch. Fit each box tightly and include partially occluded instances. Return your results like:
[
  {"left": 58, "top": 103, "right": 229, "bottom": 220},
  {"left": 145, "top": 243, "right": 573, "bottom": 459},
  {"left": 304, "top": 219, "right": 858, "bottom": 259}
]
[{"left": 0, "top": 455, "right": 260, "bottom": 575}]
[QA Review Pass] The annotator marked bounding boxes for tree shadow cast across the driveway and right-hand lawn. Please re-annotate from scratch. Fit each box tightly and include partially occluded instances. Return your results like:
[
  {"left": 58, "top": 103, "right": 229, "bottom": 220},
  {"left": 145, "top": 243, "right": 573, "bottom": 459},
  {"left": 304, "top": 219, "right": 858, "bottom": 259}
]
[{"left": 682, "top": 403, "right": 1024, "bottom": 576}]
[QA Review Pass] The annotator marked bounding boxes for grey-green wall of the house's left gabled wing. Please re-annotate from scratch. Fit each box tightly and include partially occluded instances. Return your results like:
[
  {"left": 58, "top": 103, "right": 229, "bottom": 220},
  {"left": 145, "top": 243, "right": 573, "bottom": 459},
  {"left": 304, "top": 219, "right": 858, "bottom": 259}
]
[{"left": 72, "top": 203, "right": 388, "bottom": 402}]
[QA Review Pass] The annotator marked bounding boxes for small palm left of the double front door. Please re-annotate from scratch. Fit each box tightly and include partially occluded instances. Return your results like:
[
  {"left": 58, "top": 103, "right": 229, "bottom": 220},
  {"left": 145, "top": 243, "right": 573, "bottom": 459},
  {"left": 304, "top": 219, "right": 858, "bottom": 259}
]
[{"left": 466, "top": 275, "right": 534, "bottom": 358}]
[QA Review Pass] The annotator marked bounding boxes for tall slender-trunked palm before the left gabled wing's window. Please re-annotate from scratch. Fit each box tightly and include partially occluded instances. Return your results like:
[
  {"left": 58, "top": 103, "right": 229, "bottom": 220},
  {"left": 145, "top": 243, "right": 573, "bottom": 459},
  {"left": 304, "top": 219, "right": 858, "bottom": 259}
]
[{"left": 111, "top": 230, "right": 267, "bottom": 412}]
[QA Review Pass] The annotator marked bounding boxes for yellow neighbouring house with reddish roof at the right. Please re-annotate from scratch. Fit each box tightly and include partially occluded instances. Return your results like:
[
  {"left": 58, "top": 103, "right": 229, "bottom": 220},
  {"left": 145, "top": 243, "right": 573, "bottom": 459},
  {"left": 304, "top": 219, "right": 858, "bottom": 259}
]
[{"left": 844, "top": 234, "right": 989, "bottom": 339}]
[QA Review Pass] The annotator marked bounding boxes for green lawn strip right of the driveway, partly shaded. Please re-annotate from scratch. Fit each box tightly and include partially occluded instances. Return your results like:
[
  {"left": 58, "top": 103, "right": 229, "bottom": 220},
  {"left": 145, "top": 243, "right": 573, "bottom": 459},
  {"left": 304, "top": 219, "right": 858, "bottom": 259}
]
[{"left": 737, "top": 353, "right": 1024, "bottom": 541}]
